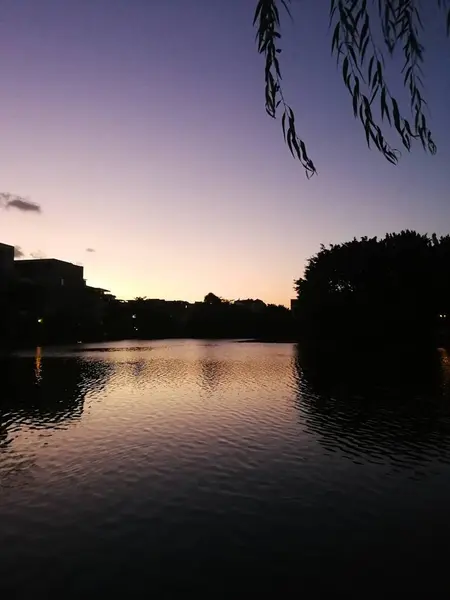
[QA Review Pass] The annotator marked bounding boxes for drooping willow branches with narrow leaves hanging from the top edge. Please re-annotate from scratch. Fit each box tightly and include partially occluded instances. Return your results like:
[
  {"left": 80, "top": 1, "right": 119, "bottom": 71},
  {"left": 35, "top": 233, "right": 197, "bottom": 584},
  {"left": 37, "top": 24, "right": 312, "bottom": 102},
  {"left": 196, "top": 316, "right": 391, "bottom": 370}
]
[{"left": 253, "top": 0, "right": 450, "bottom": 177}]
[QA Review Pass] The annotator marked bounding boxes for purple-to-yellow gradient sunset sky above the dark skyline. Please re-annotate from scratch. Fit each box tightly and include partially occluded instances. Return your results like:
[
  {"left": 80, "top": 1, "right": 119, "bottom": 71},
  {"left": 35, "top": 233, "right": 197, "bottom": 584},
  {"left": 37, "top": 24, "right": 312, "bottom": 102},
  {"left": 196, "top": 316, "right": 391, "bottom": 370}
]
[{"left": 0, "top": 0, "right": 450, "bottom": 304}]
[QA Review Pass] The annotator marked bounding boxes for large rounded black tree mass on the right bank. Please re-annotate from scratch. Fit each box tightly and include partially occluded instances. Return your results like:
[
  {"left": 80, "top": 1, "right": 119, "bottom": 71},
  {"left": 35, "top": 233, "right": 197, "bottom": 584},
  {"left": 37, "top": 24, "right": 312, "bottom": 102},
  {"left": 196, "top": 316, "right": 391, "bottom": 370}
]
[{"left": 295, "top": 230, "right": 450, "bottom": 343}]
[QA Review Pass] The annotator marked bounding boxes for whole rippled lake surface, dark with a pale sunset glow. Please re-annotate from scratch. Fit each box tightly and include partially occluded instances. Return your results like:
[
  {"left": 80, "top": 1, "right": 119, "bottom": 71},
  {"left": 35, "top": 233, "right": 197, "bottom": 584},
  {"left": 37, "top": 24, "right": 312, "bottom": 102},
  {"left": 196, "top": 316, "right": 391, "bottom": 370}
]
[{"left": 0, "top": 341, "right": 450, "bottom": 598}]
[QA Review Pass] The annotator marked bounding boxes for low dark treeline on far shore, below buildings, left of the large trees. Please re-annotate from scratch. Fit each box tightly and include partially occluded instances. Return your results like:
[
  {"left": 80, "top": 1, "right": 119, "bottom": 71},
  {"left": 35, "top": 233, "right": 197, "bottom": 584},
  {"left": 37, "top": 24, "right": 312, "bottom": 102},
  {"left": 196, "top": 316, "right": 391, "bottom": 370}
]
[{"left": 1, "top": 293, "right": 294, "bottom": 346}]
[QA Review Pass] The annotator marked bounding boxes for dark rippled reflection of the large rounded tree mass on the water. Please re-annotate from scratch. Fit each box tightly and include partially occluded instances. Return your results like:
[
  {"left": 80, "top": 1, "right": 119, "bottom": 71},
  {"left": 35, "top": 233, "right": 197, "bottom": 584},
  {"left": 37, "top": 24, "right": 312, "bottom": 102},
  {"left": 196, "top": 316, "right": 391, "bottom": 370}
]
[{"left": 295, "top": 347, "right": 450, "bottom": 467}]
